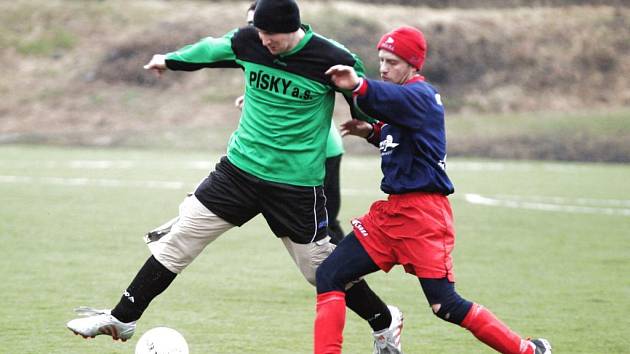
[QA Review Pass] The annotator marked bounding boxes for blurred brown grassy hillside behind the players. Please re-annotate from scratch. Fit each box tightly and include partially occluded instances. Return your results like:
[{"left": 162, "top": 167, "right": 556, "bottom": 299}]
[{"left": 0, "top": 0, "right": 630, "bottom": 160}]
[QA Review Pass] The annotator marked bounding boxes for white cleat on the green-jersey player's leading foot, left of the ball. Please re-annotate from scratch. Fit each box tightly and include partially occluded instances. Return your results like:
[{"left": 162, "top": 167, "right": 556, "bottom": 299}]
[{"left": 66, "top": 307, "right": 136, "bottom": 342}]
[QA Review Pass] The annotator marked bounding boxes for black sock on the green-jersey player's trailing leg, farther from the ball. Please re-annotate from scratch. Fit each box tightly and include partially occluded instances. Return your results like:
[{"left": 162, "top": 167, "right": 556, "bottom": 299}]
[{"left": 346, "top": 280, "right": 392, "bottom": 332}]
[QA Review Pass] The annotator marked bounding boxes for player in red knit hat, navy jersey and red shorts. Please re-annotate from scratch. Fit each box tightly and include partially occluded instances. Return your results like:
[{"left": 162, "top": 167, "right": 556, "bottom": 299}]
[{"left": 314, "top": 27, "right": 551, "bottom": 354}]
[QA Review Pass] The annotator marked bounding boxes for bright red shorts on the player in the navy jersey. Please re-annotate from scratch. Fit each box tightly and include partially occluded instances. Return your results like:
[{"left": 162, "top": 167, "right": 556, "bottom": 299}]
[{"left": 352, "top": 192, "right": 455, "bottom": 282}]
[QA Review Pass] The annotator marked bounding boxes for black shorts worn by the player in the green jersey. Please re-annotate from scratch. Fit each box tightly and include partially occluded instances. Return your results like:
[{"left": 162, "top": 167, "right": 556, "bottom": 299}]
[{"left": 195, "top": 156, "right": 328, "bottom": 244}]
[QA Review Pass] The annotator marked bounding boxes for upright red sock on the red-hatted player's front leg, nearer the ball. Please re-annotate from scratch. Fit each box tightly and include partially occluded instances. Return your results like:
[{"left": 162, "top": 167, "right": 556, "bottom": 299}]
[{"left": 314, "top": 291, "right": 346, "bottom": 354}]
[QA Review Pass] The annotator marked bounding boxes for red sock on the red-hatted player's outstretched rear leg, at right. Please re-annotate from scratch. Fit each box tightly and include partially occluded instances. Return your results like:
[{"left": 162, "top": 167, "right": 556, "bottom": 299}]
[{"left": 461, "top": 304, "right": 533, "bottom": 354}]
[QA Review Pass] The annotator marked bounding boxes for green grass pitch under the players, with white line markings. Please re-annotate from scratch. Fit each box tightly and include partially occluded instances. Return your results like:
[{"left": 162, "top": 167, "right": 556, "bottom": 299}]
[{"left": 0, "top": 146, "right": 630, "bottom": 354}]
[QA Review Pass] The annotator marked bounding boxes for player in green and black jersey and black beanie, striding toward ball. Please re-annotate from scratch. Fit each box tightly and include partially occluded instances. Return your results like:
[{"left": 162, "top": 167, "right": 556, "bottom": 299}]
[{"left": 67, "top": 0, "right": 402, "bottom": 352}]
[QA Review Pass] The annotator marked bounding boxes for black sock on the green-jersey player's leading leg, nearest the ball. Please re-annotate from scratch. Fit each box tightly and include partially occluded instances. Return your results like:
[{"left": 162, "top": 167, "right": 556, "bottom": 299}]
[{"left": 112, "top": 256, "right": 177, "bottom": 323}]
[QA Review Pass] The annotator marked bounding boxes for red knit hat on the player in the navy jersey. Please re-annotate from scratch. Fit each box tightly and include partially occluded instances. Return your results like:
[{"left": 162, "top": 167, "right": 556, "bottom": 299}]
[{"left": 376, "top": 26, "right": 427, "bottom": 70}]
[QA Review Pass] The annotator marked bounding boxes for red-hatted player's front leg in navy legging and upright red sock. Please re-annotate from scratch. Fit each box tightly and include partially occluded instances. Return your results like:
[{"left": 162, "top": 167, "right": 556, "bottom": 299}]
[{"left": 314, "top": 233, "right": 382, "bottom": 354}]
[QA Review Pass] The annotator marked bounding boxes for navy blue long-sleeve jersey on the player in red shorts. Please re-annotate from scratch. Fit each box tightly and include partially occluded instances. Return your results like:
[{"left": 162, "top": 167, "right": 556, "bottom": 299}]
[{"left": 355, "top": 75, "right": 454, "bottom": 195}]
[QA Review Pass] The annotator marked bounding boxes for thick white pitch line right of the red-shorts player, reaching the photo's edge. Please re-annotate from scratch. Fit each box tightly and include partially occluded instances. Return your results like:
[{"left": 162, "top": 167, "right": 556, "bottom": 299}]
[{"left": 464, "top": 193, "right": 630, "bottom": 216}]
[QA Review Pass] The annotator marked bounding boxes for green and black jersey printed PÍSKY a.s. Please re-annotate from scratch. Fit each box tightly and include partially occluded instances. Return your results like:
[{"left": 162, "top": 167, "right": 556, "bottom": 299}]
[{"left": 166, "top": 25, "right": 364, "bottom": 186}]
